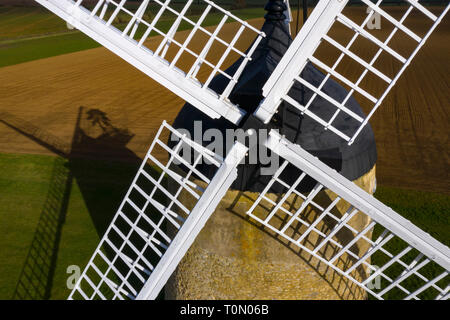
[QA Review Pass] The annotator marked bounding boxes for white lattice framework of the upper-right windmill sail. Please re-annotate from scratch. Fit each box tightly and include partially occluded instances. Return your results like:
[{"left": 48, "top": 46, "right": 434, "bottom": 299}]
[{"left": 255, "top": 0, "right": 450, "bottom": 144}]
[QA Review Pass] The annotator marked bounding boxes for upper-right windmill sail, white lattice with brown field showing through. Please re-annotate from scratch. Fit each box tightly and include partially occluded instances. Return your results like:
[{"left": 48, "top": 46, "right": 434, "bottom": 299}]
[{"left": 255, "top": 0, "right": 450, "bottom": 144}]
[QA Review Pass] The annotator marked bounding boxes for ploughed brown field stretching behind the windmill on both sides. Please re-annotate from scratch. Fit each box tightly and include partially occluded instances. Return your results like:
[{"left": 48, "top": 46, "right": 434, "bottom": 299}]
[{"left": 0, "top": 8, "right": 450, "bottom": 194}]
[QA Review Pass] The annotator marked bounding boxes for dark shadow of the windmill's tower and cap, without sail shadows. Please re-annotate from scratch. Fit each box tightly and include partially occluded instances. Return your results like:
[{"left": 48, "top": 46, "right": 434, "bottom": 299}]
[{"left": 69, "top": 107, "right": 142, "bottom": 236}]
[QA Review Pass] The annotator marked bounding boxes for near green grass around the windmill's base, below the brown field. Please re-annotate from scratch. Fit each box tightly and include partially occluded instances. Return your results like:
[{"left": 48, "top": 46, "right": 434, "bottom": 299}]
[{"left": 0, "top": 154, "right": 450, "bottom": 299}]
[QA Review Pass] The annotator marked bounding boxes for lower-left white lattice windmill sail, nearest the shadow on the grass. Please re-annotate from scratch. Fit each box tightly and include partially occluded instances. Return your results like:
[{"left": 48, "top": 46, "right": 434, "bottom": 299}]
[{"left": 69, "top": 122, "right": 247, "bottom": 299}]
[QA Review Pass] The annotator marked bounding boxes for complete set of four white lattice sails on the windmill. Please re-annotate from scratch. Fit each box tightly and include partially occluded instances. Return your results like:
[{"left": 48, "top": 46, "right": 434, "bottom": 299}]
[{"left": 32, "top": 0, "right": 450, "bottom": 299}]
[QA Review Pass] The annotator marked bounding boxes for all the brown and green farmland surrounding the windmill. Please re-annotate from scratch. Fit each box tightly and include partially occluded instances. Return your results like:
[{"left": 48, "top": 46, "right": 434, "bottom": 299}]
[{"left": 0, "top": 7, "right": 450, "bottom": 299}]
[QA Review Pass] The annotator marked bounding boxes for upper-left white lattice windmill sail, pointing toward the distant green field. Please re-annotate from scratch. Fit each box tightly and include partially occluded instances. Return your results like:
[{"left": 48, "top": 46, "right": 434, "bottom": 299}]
[{"left": 36, "top": 0, "right": 264, "bottom": 123}]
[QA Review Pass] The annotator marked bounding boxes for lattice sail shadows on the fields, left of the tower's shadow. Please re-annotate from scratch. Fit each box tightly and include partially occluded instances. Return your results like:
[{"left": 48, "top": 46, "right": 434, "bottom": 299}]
[{"left": 0, "top": 112, "right": 73, "bottom": 300}]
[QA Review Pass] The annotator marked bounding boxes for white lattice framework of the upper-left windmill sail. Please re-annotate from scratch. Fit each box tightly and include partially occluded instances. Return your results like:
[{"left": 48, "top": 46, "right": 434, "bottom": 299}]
[{"left": 35, "top": 0, "right": 265, "bottom": 124}]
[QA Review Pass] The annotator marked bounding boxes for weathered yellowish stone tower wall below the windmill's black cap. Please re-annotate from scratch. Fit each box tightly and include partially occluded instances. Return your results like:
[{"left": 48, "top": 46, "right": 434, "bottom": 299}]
[{"left": 165, "top": 167, "right": 375, "bottom": 299}]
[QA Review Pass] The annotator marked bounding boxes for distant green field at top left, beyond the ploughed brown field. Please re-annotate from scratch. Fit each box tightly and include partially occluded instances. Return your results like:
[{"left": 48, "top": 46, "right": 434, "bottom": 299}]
[{"left": 0, "top": 7, "right": 264, "bottom": 67}]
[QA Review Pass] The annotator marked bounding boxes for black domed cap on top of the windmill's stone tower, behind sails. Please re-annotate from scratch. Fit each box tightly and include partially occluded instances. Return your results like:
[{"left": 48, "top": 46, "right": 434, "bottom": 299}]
[{"left": 172, "top": 1, "right": 377, "bottom": 193}]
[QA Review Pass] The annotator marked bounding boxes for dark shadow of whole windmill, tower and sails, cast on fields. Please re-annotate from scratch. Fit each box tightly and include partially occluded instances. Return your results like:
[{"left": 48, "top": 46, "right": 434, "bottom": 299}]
[{"left": 0, "top": 107, "right": 142, "bottom": 300}]
